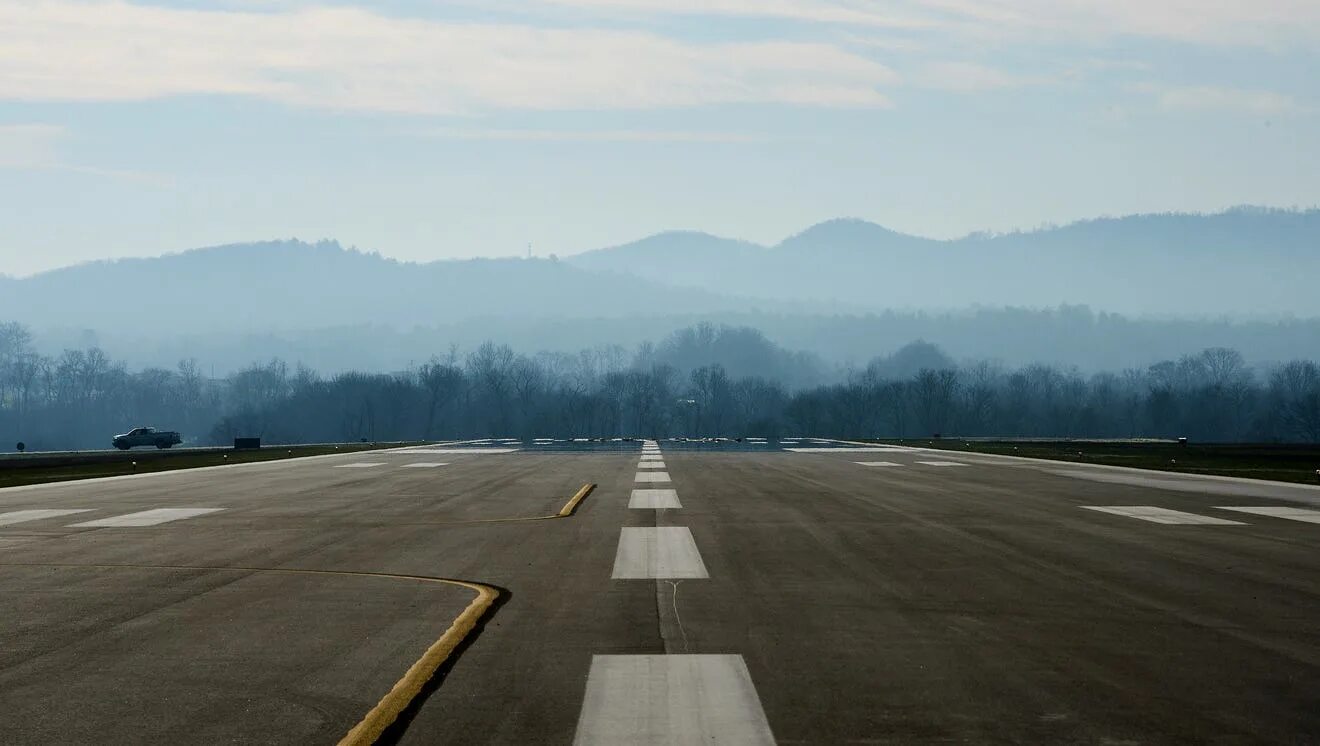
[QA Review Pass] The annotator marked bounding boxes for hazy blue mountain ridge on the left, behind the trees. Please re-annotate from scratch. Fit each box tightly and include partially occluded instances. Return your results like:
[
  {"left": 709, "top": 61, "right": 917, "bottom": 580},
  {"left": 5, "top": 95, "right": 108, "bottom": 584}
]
[{"left": 0, "top": 240, "right": 786, "bottom": 334}]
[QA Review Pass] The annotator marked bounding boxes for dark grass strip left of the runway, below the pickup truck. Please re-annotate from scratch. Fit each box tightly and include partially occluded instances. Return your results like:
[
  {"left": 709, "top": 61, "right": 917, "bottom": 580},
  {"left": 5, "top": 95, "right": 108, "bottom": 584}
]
[{"left": 0, "top": 444, "right": 421, "bottom": 487}]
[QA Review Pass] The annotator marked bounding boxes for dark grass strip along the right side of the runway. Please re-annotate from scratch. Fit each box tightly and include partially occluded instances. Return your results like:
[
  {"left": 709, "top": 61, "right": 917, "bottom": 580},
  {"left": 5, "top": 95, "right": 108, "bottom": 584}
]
[{"left": 876, "top": 438, "right": 1320, "bottom": 485}]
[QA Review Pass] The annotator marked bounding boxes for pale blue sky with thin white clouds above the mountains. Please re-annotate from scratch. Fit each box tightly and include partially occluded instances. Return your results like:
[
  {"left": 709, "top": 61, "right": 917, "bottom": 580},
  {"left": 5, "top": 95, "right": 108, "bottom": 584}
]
[{"left": 0, "top": 0, "right": 1320, "bottom": 275}]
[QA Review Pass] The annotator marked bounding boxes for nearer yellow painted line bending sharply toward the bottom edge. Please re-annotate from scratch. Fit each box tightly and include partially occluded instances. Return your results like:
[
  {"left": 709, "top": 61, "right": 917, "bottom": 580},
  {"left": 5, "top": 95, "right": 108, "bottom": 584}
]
[{"left": 0, "top": 559, "right": 496, "bottom": 746}]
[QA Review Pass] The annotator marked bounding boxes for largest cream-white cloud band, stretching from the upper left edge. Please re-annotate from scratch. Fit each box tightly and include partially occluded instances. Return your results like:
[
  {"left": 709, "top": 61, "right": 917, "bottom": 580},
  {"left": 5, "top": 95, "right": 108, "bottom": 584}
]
[{"left": 0, "top": 0, "right": 895, "bottom": 114}]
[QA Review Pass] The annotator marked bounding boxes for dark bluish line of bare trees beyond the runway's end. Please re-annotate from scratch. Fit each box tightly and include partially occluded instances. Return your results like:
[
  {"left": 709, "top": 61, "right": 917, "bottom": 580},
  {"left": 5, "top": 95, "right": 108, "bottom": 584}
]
[{"left": 0, "top": 323, "right": 1320, "bottom": 450}]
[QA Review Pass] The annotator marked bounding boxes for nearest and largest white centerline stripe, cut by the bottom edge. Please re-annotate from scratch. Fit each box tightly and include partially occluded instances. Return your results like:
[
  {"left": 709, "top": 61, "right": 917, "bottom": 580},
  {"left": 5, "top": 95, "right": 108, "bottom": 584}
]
[{"left": 573, "top": 655, "right": 775, "bottom": 746}]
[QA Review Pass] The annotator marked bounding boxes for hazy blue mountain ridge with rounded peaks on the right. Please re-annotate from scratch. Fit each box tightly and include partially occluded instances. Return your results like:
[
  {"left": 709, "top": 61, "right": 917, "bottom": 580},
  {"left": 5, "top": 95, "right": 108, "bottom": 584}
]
[{"left": 570, "top": 207, "right": 1320, "bottom": 316}]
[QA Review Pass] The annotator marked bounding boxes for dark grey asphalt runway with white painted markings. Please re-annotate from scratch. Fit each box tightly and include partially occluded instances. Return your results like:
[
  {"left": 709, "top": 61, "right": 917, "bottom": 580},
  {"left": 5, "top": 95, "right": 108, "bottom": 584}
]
[{"left": 0, "top": 440, "right": 1320, "bottom": 745}]
